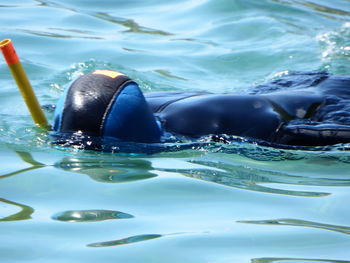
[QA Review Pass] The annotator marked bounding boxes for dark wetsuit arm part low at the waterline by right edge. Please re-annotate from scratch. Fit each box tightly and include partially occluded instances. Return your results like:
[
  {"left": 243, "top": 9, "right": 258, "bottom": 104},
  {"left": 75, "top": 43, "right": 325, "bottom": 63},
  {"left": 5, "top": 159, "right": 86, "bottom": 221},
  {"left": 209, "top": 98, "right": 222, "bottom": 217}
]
[{"left": 276, "top": 124, "right": 350, "bottom": 146}]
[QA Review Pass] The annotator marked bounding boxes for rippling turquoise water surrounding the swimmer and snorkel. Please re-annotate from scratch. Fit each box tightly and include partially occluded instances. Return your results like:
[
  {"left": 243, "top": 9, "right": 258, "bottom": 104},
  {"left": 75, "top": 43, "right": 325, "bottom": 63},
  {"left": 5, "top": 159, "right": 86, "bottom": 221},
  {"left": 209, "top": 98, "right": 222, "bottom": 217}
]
[{"left": 0, "top": 0, "right": 350, "bottom": 263}]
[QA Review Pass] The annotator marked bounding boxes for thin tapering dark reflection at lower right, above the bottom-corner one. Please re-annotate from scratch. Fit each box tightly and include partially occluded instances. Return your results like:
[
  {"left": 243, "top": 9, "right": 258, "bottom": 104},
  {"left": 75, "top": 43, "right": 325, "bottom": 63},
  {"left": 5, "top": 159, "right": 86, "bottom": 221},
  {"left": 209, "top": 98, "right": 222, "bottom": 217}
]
[{"left": 237, "top": 218, "right": 350, "bottom": 235}]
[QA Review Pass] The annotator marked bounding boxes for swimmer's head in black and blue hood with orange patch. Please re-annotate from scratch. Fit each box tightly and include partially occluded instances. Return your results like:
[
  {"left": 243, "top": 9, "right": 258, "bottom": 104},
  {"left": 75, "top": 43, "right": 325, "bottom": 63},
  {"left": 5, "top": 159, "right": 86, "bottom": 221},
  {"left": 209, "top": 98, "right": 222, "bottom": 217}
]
[{"left": 54, "top": 70, "right": 161, "bottom": 143}]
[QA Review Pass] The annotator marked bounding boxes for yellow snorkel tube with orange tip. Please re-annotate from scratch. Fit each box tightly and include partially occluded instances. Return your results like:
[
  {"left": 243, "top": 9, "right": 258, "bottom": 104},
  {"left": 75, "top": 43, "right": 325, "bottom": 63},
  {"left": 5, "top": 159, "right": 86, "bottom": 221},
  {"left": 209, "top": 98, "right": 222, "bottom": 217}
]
[{"left": 0, "top": 39, "right": 49, "bottom": 129}]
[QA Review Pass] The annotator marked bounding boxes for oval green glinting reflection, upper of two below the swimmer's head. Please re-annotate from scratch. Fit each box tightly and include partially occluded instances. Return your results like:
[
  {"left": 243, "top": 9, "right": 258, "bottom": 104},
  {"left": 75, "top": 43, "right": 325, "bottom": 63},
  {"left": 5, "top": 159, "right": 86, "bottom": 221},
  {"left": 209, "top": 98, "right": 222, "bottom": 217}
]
[{"left": 52, "top": 210, "right": 134, "bottom": 222}]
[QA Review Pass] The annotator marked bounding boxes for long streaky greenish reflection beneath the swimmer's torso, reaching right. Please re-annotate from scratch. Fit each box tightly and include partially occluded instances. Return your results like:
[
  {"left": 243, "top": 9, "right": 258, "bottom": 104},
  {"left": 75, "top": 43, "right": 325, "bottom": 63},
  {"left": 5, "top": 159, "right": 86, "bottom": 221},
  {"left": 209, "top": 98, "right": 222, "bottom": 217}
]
[{"left": 158, "top": 159, "right": 350, "bottom": 197}]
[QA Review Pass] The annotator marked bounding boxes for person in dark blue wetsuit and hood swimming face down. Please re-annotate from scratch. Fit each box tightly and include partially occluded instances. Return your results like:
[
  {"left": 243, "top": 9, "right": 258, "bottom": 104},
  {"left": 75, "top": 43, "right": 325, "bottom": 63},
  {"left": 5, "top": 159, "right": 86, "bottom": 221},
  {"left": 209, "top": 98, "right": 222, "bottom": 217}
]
[{"left": 53, "top": 70, "right": 350, "bottom": 146}]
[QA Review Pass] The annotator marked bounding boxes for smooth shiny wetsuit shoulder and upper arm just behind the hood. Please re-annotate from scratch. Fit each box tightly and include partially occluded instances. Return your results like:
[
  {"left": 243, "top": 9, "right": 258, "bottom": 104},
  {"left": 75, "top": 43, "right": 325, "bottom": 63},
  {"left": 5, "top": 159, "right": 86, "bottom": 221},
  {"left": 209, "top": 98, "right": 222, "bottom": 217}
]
[{"left": 158, "top": 94, "right": 281, "bottom": 140}]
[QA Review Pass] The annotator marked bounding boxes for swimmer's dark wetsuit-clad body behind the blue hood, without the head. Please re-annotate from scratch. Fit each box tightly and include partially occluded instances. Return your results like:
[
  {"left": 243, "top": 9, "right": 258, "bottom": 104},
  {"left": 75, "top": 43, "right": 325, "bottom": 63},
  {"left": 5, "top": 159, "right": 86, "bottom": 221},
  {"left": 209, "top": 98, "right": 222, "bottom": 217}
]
[{"left": 146, "top": 73, "right": 350, "bottom": 145}]
